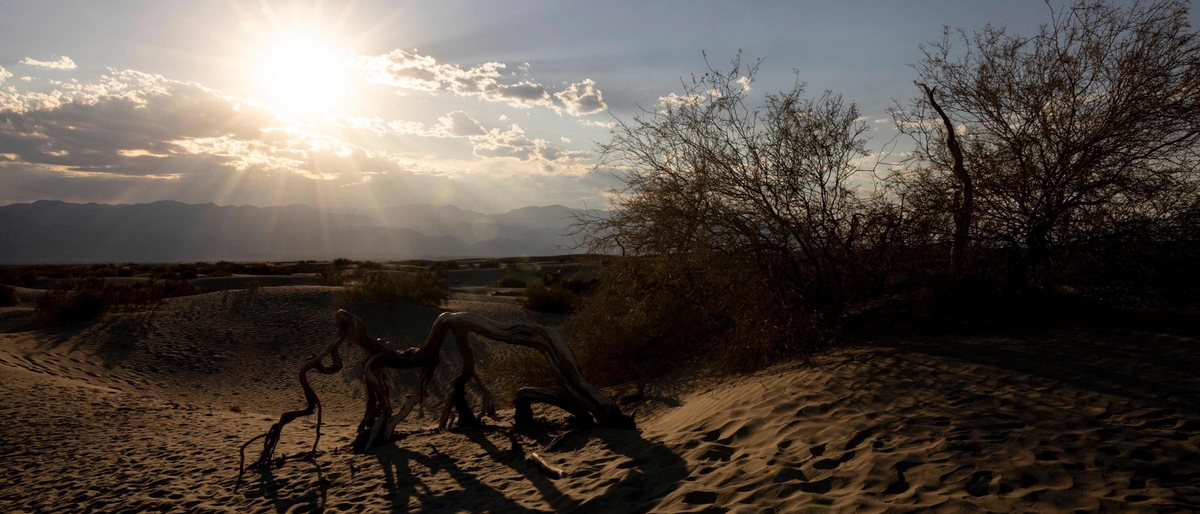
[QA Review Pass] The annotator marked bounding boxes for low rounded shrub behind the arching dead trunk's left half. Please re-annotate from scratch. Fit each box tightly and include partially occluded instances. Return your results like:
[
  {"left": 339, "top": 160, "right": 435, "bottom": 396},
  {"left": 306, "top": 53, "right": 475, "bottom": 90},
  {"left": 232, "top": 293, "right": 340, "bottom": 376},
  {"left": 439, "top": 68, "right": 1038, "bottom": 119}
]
[{"left": 341, "top": 271, "right": 450, "bottom": 307}]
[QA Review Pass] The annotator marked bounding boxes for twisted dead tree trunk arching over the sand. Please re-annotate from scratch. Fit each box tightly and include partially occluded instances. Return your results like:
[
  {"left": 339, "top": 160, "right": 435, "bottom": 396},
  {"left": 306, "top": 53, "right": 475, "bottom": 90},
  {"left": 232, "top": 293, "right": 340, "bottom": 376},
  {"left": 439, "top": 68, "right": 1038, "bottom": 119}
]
[{"left": 242, "top": 310, "right": 635, "bottom": 467}]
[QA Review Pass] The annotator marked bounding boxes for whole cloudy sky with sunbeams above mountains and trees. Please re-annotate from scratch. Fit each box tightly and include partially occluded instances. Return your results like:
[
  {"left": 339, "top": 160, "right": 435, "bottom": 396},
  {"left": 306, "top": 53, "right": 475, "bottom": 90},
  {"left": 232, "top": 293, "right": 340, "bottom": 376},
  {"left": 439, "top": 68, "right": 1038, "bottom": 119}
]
[{"left": 0, "top": 0, "right": 1180, "bottom": 214}]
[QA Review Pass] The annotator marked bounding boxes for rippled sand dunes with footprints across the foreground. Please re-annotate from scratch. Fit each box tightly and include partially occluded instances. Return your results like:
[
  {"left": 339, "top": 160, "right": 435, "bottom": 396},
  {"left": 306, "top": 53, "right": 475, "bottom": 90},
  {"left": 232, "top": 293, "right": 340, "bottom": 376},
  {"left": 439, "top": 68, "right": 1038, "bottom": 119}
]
[{"left": 0, "top": 287, "right": 1200, "bottom": 513}]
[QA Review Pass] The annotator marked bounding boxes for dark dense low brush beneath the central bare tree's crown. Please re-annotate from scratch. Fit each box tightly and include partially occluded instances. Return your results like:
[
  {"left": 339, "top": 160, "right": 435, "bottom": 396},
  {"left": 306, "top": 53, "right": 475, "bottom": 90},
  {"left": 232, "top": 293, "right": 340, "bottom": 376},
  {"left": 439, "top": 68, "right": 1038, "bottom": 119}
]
[{"left": 564, "top": 256, "right": 830, "bottom": 384}]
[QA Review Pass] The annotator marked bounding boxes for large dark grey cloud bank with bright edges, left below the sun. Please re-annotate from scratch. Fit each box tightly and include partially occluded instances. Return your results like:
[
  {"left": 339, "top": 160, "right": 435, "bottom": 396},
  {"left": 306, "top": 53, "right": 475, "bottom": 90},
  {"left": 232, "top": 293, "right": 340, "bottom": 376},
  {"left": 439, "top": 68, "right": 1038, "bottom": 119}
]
[{"left": 0, "top": 70, "right": 427, "bottom": 189}]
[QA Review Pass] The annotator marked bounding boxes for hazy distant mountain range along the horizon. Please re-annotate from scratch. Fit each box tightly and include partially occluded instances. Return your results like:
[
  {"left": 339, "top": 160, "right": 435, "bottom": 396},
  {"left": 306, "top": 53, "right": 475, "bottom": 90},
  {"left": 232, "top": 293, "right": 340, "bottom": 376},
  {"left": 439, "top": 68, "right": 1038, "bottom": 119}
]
[{"left": 0, "top": 201, "right": 605, "bottom": 264}]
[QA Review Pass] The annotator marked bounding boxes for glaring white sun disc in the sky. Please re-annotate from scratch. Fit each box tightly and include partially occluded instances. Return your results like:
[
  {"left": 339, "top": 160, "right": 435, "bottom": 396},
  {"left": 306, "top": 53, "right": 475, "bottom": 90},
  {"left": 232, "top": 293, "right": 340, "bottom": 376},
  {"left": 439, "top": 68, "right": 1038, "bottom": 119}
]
[{"left": 253, "top": 32, "right": 352, "bottom": 116}]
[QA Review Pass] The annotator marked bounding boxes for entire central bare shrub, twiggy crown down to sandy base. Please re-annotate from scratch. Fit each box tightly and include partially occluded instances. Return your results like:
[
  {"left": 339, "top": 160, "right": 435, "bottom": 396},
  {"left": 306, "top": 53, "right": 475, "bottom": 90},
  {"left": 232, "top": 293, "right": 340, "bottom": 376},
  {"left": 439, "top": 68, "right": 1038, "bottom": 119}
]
[{"left": 570, "top": 60, "right": 887, "bottom": 379}]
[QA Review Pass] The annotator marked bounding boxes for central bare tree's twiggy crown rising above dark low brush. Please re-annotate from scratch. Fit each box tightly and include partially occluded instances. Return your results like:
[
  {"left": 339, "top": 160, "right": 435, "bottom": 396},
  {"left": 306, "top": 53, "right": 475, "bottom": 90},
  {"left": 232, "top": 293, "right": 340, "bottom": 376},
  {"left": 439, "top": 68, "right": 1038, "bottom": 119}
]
[{"left": 586, "top": 60, "right": 868, "bottom": 317}]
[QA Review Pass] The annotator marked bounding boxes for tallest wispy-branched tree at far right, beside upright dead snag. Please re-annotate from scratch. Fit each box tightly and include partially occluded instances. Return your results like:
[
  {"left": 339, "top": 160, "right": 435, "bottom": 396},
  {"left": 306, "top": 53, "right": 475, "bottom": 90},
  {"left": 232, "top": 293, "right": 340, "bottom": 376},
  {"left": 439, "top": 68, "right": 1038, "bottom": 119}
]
[{"left": 892, "top": 0, "right": 1200, "bottom": 291}]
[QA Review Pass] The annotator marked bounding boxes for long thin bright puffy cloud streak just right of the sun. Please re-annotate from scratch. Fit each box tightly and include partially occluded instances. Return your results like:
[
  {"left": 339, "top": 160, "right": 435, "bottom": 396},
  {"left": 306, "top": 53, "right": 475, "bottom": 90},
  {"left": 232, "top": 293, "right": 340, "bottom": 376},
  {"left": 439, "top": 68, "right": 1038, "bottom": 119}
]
[{"left": 349, "top": 49, "right": 607, "bottom": 116}]
